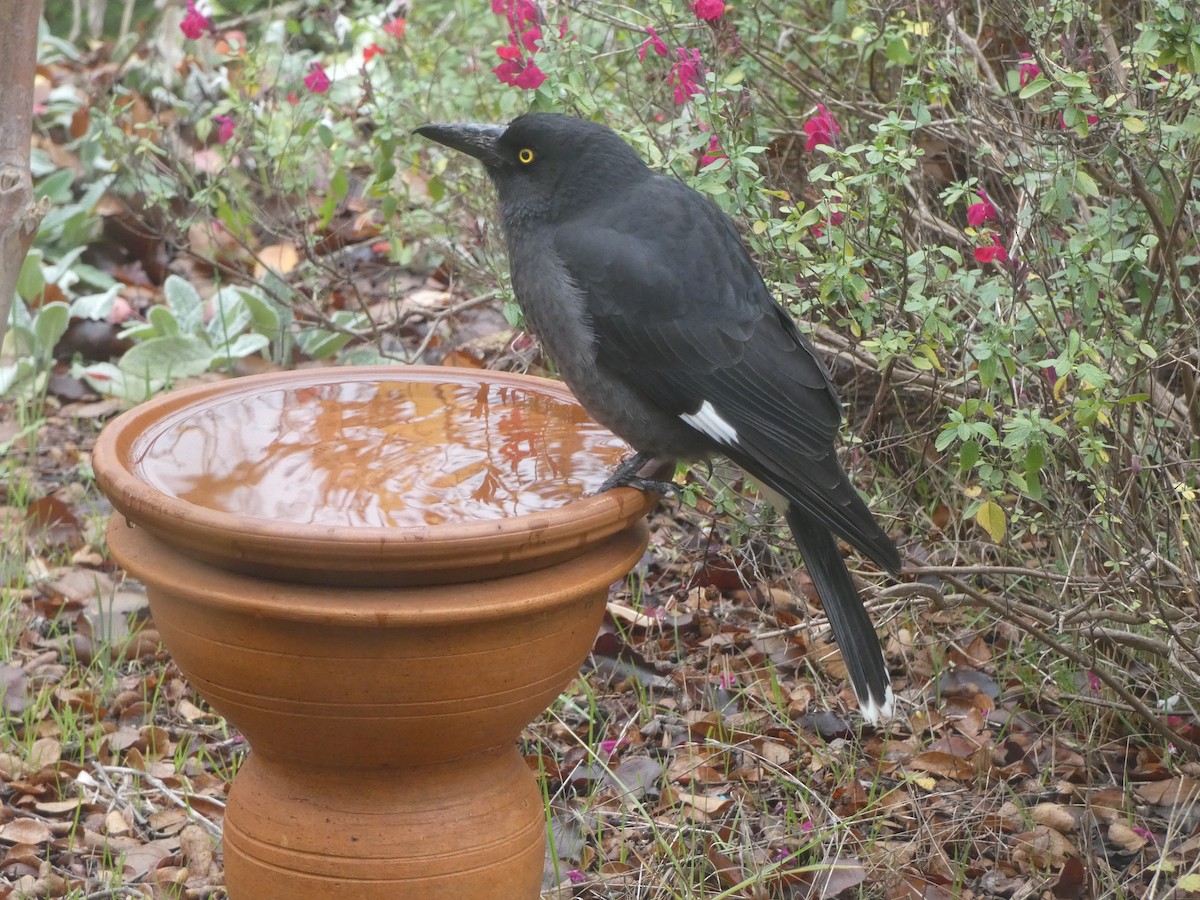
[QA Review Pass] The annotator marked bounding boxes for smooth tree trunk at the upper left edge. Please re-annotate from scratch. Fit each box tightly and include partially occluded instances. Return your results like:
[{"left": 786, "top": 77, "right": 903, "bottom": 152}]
[{"left": 0, "top": 0, "right": 46, "bottom": 343}]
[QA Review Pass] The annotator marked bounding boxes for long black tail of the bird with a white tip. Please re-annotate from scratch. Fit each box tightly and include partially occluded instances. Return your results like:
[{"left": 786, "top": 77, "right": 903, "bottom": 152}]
[{"left": 787, "top": 503, "right": 894, "bottom": 722}]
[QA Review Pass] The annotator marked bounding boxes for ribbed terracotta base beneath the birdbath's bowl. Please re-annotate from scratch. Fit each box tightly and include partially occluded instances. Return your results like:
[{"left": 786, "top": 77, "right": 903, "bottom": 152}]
[{"left": 224, "top": 745, "right": 546, "bottom": 900}]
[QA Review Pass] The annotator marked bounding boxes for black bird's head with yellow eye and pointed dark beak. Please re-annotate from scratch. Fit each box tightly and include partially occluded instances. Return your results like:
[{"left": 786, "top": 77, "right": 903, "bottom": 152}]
[{"left": 416, "top": 113, "right": 650, "bottom": 224}]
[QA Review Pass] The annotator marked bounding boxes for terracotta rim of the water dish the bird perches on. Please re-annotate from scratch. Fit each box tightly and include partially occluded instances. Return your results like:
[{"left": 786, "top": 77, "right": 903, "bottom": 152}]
[{"left": 92, "top": 366, "right": 658, "bottom": 586}]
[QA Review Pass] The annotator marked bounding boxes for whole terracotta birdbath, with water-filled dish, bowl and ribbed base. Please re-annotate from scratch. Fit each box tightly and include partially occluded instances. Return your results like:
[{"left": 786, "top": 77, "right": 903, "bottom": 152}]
[{"left": 94, "top": 367, "right": 655, "bottom": 900}]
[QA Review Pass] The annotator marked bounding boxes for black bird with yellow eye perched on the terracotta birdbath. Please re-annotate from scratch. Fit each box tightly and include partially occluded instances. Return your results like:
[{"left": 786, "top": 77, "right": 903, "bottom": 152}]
[{"left": 416, "top": 113, "right": 900, "bottom": 722}]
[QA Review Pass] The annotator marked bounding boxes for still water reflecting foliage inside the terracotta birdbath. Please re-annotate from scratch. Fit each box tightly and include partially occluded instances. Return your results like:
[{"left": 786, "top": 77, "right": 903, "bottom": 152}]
[{"left": 133, "top": 373, "right": 628, "bottom": 527}]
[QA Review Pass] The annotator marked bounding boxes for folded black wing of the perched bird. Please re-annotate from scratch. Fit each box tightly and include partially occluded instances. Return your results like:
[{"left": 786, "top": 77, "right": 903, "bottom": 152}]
[{"left": 553, "top": 178, "right": 900, "bottom": 570}]
